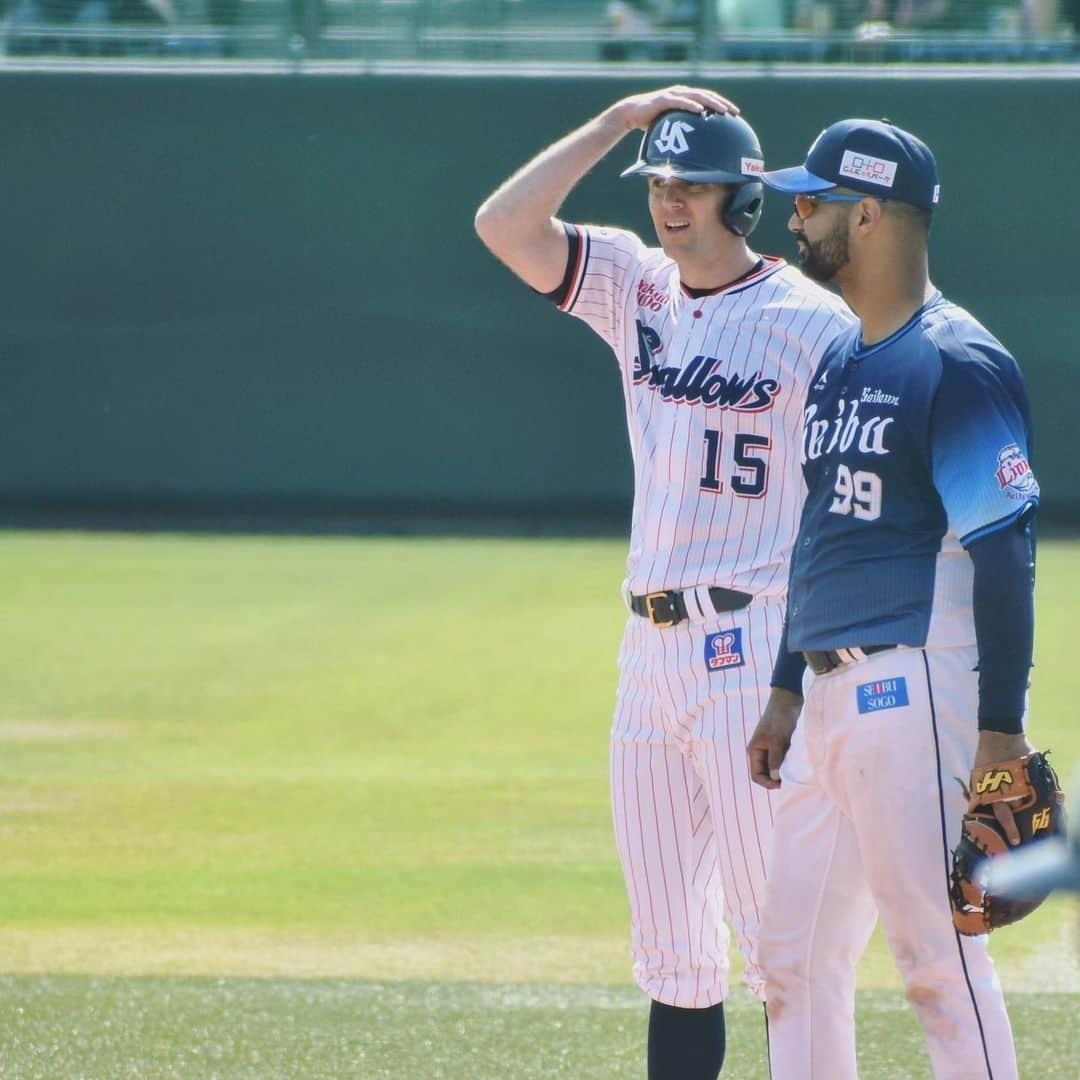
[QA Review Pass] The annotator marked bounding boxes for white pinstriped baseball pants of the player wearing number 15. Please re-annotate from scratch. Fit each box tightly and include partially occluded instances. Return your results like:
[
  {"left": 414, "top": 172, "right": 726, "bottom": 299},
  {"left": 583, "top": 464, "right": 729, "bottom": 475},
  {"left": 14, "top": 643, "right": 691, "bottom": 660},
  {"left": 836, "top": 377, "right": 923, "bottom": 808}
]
[{"left": 611, "top": 598, "right": 784, "bottom": 1009}]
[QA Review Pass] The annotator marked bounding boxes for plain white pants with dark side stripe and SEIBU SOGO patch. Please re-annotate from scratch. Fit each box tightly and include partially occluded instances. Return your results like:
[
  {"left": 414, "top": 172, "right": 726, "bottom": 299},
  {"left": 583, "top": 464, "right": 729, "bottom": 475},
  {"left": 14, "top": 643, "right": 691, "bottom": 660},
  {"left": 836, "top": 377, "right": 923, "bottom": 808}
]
[{"left": 759, "top": 648, "right": 1017, "bottom": 1080}]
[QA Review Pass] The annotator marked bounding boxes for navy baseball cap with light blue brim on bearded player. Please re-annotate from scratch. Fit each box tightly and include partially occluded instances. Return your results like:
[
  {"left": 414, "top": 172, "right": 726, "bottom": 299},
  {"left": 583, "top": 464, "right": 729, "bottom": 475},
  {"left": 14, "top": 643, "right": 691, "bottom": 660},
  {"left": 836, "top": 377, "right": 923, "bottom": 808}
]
[{"left": 760, "top": 120, "right": 941, "bottom": 210}]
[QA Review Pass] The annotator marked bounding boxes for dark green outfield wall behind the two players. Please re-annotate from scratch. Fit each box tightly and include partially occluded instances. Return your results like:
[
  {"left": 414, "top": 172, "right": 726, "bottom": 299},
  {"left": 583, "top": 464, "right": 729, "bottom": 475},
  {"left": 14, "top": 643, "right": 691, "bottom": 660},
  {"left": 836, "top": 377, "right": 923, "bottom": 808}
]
[{"left": 0, "top": 73, "right": 1080, "bottom": 523}]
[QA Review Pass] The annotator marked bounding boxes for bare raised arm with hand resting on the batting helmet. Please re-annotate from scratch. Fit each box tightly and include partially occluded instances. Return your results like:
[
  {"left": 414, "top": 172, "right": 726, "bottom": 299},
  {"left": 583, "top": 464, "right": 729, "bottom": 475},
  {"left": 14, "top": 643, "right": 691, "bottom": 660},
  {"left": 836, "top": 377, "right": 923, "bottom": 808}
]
[{"left": 475, "top": 86, "right": 738, "bottom": 293}]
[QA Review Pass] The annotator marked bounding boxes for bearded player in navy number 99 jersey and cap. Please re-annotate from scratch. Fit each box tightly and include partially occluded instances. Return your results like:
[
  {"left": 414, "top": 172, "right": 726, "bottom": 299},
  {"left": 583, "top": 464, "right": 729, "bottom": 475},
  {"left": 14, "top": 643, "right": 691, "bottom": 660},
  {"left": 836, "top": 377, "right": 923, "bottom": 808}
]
[{"left": 750, "top": 120, "right": 1039, "bottom": 1080}]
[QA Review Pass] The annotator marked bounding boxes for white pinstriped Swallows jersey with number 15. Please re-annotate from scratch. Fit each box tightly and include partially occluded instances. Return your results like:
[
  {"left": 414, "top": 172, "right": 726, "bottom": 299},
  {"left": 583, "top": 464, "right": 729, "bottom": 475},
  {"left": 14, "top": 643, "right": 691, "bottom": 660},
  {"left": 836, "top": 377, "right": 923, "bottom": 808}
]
[{"left": 558, "top": 226, "right": 854, "bottom": 596}]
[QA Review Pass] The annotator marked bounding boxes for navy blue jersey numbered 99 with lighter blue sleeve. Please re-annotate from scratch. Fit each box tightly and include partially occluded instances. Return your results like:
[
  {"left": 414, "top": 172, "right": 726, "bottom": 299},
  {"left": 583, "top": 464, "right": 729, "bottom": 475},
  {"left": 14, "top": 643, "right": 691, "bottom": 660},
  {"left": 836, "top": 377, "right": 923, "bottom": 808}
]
[{"left": 788, "top": 294, "right": 1039, "bottom": 650}]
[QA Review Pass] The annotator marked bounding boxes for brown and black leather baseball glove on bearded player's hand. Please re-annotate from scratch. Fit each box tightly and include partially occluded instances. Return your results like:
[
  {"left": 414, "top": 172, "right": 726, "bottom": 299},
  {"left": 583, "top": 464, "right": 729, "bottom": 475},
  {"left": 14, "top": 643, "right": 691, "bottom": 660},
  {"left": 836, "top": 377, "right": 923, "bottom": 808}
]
[{"left": 949, "top": 752, "right": 1065, "bottom": 934}]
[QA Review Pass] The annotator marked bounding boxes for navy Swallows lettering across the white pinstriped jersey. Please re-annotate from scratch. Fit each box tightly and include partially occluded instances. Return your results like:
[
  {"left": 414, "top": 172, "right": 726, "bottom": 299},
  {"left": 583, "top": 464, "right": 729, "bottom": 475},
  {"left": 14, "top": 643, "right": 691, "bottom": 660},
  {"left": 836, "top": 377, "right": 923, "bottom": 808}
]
[{"left": 634, "top": 320, "right": 781, "bottom": 413}]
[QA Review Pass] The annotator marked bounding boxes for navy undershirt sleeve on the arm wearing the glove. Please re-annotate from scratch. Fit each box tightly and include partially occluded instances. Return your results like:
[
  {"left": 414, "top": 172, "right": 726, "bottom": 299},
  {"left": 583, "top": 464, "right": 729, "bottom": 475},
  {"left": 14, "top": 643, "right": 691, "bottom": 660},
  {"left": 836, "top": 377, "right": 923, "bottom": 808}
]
[{"left": 968, "top": 517, "right": 1035, "bottom": 734}]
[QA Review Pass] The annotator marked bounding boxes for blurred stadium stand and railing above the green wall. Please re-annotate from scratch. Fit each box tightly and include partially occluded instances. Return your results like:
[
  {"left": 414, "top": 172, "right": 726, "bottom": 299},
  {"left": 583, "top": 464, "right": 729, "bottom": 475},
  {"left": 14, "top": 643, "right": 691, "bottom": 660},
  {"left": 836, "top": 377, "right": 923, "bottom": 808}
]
[{"left": 0, "top": 0, "right": 1078, "bottom": 65}]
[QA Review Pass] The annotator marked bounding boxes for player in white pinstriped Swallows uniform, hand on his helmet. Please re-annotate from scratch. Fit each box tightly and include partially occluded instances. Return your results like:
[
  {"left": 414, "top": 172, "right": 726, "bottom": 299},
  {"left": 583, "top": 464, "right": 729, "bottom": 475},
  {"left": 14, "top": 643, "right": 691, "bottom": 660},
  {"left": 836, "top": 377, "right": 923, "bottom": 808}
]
[{"left": 476, "top": 86, "right": 853, "bottom": 1080}]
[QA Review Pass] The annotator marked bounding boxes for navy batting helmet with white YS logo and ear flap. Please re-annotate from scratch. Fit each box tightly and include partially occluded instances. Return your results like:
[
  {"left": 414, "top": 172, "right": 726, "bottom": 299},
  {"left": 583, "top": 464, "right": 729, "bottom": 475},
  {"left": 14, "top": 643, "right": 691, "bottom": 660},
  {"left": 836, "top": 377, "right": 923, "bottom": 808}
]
[{"left": 622, "top": 109, "right": 765, "bottom": 237}]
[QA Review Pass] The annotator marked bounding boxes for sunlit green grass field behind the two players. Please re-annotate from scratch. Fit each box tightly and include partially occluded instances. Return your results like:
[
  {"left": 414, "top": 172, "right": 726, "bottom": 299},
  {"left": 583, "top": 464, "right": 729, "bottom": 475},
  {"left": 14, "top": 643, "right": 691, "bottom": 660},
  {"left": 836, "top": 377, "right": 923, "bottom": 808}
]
[{"left": 0, "top": 534, "right": 1080, "bottom": 1080}]
